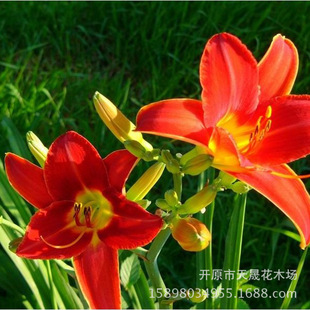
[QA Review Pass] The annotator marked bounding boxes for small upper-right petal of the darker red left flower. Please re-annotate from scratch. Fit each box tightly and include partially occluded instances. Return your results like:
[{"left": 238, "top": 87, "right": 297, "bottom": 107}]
[{"left": 103, "top": 150, "right": 139, "bottom": 193}]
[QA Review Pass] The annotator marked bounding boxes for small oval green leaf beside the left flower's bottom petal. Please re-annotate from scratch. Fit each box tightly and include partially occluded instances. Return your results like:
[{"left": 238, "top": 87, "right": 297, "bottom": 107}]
[{"left": 120, "top": 254, "right": 140, "bottom": 289}]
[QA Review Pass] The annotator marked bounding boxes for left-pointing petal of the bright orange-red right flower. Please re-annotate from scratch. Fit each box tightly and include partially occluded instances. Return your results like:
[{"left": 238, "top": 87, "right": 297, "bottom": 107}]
[{"left": 137, "top": 99, "right": 208, "bottom": 145}]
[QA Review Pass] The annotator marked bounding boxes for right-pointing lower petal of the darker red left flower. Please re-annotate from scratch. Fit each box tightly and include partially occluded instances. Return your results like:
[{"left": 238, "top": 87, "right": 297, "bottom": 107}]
[{"left": 98, "top": 194, "right": 163, "bottom": 249}]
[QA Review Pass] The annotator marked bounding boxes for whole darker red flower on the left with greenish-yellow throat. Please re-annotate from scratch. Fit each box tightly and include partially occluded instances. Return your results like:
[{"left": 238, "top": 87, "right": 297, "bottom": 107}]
[{"left": 5, "top": 132, "right": 162, "bottom": 309}]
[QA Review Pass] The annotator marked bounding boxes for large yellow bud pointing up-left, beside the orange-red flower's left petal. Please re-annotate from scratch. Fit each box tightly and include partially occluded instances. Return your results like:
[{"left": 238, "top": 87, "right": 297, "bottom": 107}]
[{"left": 93, "top": 92, "right": 153, "bottom": 151}]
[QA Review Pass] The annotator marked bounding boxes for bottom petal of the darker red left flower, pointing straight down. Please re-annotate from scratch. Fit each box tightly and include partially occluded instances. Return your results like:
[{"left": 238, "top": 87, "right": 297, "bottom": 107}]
[{"left": 73, "top": 242, "right": 121, "bottom": 309}]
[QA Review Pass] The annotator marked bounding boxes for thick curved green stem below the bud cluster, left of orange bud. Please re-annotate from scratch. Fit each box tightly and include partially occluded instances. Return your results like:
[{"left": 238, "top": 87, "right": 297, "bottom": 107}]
[{"left": 144, "top": 227, "right": 172, "bottom": 309}]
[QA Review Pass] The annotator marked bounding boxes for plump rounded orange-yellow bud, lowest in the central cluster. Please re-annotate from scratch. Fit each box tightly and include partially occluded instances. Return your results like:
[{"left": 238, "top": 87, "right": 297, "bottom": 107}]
[{"left": 171, "top": 217, "right": 211, "bottom": 252}]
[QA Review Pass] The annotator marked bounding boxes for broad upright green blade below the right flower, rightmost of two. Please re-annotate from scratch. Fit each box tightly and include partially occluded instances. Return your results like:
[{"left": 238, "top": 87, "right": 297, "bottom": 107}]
[{"left": 221, "top": 194, "right": 247, "bottom": 309}]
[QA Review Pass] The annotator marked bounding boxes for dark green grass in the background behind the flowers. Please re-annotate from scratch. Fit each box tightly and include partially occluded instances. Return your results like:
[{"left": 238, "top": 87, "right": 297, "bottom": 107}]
[{"left": 0, "top": 2, "right": 310, "bottom": 308}]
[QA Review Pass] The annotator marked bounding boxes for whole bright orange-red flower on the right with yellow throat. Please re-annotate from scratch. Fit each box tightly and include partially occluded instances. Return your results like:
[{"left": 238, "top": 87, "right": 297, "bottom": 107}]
[{"left": 137, "top": 33, "right": 310, "bottom": 248}]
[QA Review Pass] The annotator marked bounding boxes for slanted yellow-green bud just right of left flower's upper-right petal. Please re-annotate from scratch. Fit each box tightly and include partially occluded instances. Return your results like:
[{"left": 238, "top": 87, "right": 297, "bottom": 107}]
[{"left": 126, "top": 162, "right": 165, "bottom": 201}]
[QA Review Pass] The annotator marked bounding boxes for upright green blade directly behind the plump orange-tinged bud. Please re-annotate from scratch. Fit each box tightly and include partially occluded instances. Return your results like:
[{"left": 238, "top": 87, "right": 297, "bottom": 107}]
[{"left": 196, "top": 168, "right": 215, "bottom": 309}]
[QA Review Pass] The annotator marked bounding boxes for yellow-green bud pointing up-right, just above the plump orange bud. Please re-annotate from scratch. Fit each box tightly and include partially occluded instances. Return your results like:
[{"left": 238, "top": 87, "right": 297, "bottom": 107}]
[{"left": 178, "top": 184, "right": 217, "bottom": 214}]
